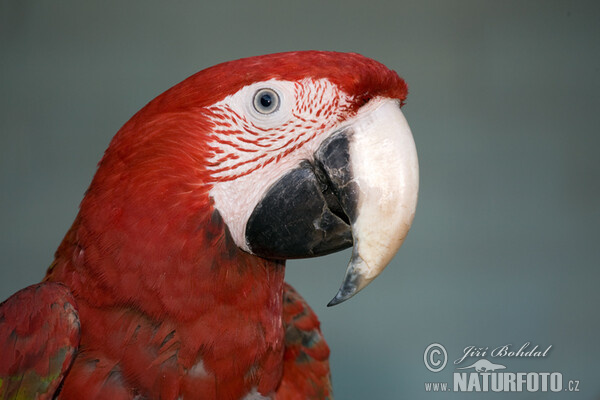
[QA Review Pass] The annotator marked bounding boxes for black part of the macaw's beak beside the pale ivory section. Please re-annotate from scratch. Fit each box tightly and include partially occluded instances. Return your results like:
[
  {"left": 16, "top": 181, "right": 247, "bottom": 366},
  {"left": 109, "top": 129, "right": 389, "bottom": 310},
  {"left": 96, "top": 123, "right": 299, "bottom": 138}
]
[{"left": 246, "top": 131, "right": 357, "bottom": 259}]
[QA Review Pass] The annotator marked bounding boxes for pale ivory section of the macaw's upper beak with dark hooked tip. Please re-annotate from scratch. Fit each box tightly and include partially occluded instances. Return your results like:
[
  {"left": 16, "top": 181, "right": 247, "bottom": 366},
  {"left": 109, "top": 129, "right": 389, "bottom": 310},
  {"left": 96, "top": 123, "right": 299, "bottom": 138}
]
[{"left": 328, "top": 100, "right": 419, "bottom": 306}]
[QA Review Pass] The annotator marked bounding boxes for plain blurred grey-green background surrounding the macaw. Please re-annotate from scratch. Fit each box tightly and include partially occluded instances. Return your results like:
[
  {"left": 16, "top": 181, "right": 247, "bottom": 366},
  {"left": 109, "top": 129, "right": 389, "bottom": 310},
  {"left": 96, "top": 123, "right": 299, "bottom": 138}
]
[{"left": 0, "top": 0, "right": 600, "bottom": 399}]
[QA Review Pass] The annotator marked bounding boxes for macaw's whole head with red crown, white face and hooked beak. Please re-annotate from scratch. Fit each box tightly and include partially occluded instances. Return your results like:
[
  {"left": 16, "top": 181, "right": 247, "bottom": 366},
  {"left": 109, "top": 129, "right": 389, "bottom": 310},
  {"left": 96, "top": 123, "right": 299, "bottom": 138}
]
[{"left": 82, "top": 51, "right": 418, "bottom": 305}]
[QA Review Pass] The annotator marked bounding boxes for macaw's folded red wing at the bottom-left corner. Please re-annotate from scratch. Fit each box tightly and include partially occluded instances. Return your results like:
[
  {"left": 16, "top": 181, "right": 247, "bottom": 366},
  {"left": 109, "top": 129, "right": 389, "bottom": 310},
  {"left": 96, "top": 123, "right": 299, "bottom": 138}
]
[{"left": 0, "top": 283, "right": 80, "bottom": 400}]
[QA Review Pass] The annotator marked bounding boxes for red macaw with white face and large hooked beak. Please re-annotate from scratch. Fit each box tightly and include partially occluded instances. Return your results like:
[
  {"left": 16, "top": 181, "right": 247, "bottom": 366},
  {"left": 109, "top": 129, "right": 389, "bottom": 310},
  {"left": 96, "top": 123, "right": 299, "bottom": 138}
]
[{"left": 0, "top": 51, "right": 418, "bottom": 400}]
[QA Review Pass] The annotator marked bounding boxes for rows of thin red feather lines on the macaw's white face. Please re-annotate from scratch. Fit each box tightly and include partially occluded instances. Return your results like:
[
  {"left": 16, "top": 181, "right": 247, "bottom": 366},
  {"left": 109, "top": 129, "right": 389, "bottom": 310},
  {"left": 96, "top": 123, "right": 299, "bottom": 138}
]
[{"left": 207, "top": 79, "right": 353, "bottom": 182}]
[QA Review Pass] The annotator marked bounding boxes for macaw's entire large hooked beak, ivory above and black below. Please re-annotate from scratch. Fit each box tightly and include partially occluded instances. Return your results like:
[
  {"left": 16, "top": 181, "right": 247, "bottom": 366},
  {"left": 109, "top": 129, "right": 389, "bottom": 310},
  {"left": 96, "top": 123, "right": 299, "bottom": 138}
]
[{"left": 246, "top": 99, "right": 419, "bottom": 306}]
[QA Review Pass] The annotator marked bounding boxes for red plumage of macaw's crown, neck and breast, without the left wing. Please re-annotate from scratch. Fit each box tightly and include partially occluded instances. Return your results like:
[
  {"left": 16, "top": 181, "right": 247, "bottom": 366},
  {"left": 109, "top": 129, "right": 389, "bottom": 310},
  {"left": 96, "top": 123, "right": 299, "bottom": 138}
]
[{"left": 0, "top": 51, "right": 407, "bottom": 400}]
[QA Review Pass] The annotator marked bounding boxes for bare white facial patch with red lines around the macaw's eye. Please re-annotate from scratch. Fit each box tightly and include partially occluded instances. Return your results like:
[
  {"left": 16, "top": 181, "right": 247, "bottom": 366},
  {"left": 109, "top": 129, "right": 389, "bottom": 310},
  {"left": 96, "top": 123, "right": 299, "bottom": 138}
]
[{"left": 208, "top": 79, "right": 350, "bottom": 251}]
